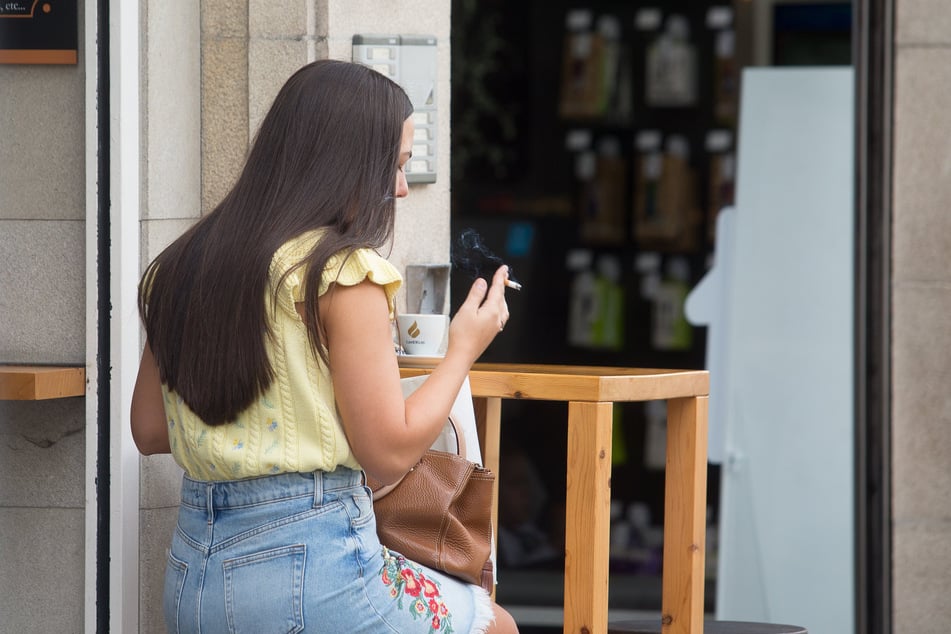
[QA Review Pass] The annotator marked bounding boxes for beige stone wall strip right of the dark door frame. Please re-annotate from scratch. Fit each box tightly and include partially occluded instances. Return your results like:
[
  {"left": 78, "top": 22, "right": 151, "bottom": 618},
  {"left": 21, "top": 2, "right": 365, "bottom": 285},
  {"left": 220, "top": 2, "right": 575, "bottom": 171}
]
[{"left": 892, "top": 0, "right": 951, "bottom": 634}]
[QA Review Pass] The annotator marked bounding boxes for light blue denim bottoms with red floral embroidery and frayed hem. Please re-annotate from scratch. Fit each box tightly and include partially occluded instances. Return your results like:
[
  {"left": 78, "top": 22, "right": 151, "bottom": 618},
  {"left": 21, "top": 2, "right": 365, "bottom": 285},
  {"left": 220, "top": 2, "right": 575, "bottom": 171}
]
[{"left": 164, "top": 468, "right": 491, "bottom": 634}]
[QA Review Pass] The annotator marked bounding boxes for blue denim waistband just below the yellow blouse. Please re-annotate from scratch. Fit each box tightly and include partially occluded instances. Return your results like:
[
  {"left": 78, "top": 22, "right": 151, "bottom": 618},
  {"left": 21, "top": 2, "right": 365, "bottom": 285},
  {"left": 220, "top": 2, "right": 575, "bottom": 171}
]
[{"left": 182, "top": 467, "right": 365, "bottom": 510}]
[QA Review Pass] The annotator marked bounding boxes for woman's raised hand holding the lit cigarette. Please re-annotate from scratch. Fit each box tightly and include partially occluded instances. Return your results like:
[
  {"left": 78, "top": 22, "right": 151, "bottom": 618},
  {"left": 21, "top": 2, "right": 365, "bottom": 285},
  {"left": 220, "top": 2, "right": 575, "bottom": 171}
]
[{"left": 446, "top": 265, "right": 509, "bottom": 365}]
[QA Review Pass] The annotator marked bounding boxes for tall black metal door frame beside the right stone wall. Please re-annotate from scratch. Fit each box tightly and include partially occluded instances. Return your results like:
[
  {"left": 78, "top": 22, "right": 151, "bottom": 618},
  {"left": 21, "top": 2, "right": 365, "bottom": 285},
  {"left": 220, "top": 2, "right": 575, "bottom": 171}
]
[{"left": 853, "top": 0, "right": 894, "bottom": 634}]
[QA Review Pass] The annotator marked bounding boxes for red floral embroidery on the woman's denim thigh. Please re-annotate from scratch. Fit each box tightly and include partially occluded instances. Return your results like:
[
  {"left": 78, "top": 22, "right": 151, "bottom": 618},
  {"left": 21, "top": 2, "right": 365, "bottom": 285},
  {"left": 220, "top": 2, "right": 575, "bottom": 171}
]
[{"left": 380, "top": 546, "right": 455, "bottom": 634}]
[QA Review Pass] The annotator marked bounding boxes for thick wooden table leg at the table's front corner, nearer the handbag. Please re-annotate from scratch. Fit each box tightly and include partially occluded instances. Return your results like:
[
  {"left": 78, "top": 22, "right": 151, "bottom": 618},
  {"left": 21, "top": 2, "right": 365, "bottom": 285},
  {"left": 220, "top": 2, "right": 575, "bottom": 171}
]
[{"left": 564, "top": 401, "right": 613, "bottom": 634}]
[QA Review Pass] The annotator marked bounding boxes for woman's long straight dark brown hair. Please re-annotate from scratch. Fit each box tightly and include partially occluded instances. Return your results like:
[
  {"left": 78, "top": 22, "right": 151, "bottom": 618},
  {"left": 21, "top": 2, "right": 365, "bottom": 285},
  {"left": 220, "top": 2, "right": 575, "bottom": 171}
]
[{"left": 139, "top": 60, "right": 412, "bottom": 425}]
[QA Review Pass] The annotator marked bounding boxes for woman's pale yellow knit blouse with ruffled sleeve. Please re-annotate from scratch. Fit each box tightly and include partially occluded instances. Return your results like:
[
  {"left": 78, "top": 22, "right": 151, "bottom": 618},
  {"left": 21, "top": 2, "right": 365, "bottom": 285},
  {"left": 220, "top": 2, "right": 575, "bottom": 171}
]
[{"left": 163, "top": 231, "right": 402, "bottom": 480}]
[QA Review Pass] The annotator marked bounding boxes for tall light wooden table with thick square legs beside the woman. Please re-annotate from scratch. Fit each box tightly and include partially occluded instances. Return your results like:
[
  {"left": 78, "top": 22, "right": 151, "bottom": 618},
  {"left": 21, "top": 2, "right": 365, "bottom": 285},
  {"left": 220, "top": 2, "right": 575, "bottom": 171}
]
[{"left": 401, "top": 361, "right": 710, "bottom": 634}]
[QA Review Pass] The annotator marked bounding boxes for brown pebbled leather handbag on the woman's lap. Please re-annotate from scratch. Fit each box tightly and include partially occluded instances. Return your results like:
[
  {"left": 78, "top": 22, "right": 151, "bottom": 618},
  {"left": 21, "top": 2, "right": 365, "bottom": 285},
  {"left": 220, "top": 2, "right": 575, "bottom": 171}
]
[{"left": 368, "top": 380, "right": 495, "bottom": 592}]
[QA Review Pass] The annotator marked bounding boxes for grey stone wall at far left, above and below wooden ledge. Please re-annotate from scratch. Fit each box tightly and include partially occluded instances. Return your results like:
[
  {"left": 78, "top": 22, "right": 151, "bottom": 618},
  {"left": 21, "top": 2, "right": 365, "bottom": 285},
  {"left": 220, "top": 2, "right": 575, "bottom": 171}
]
[{"left": 0, "top": 2, "right": 86, "bottom": 632}]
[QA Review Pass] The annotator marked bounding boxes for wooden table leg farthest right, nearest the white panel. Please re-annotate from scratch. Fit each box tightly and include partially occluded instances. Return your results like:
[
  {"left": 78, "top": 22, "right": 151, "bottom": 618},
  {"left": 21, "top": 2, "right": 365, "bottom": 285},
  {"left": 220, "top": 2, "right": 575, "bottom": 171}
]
[{"left": 661, "top": 396, "right": 707, "bottom": 634}]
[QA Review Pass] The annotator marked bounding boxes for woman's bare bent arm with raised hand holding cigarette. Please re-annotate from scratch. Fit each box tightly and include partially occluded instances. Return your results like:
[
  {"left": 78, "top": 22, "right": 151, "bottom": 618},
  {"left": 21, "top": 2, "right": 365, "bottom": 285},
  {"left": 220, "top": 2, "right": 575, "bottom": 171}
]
[{"left": 320, "top": 267, "right": 508, "bottom": 483}]
